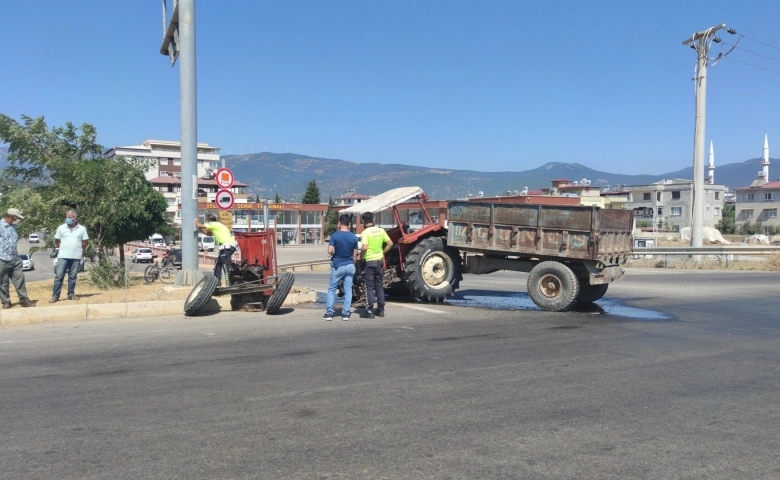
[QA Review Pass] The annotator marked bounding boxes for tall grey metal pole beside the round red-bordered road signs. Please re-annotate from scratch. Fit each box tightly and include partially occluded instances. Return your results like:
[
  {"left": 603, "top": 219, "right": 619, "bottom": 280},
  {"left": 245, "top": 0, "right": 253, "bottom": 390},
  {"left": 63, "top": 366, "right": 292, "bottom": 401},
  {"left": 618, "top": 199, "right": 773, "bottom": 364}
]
[{"left": 160, "top": 0, "right": 203, "bottom": 285}]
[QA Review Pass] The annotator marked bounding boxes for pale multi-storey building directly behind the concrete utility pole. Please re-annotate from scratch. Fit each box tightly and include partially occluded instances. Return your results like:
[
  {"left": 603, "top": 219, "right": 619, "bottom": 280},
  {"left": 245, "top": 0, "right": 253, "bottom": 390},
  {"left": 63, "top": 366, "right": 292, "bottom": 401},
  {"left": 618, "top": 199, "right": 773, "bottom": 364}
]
[{"left": 623, "top": 178, "right": 726, "bottom": 231}]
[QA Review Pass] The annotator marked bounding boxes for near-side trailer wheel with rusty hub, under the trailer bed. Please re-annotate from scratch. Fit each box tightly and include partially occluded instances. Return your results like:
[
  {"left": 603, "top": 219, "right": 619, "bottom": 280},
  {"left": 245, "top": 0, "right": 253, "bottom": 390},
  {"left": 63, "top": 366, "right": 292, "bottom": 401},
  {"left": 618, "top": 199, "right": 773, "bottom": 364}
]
[{"left": 527, "top": 262, "right": 580, "bottom": 312}]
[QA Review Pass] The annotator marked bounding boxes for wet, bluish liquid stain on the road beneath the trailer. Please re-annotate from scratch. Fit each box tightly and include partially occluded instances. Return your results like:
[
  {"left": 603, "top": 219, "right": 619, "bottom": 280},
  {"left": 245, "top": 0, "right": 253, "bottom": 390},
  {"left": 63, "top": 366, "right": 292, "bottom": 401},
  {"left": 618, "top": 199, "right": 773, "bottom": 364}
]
[{"left": 446, "top": 290, "right": 674, "bottom": 322}]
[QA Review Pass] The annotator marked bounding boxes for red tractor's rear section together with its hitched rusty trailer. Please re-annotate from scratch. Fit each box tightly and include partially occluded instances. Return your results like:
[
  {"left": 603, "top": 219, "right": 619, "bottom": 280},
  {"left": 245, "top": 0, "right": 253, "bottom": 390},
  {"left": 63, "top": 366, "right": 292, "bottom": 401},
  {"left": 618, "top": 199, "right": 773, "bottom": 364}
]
[{"left": 339, "top": 187, "right": 633, "bottom": 311}]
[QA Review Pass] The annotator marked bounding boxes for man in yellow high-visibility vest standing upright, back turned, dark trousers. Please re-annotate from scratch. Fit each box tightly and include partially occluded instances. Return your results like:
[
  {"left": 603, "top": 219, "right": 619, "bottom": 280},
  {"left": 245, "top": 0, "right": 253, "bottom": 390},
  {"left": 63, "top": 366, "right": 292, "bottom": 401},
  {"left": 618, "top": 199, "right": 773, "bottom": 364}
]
[{"left": 360, "top": 212, "right": 393, "bottom": 318}]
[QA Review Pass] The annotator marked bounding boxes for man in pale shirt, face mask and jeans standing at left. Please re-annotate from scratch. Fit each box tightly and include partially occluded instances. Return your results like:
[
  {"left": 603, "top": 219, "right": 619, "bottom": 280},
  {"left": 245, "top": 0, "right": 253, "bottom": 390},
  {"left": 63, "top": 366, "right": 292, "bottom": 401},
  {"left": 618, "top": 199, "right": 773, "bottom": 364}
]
[{"left": 49, "top": 210, "right": 89, "bottom": 303}]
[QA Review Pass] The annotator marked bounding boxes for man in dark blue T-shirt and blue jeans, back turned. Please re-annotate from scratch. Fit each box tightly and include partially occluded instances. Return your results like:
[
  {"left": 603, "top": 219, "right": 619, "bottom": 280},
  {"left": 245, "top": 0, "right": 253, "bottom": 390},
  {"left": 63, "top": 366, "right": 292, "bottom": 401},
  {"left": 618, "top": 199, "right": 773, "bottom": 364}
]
[{"left": 322, "top": 215, "right": 360, "bottom": 321}]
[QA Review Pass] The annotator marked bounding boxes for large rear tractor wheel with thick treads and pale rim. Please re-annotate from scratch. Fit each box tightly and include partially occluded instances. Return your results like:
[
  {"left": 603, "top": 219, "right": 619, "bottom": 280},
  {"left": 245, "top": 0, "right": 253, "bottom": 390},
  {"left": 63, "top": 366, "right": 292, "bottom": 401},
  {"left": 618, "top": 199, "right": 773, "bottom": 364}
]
[{"left": 404, "top": 237, "right": 461, "bottom": 302}]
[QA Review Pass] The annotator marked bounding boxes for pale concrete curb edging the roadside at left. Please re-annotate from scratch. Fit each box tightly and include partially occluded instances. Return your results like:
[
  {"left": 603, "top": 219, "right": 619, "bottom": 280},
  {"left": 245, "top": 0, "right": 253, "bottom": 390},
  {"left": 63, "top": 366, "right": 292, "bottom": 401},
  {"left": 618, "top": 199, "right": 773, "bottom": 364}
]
[{"left": 0, "top": 291, "right": 317, "bottom": 327}]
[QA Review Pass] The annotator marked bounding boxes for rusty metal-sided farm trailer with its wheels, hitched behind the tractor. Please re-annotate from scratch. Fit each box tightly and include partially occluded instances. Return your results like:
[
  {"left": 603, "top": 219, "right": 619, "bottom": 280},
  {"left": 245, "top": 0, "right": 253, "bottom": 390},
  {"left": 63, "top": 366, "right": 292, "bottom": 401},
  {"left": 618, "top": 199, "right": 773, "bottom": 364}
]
[{"left": 447, "top": 202, "right": 633, "bottom": 311}]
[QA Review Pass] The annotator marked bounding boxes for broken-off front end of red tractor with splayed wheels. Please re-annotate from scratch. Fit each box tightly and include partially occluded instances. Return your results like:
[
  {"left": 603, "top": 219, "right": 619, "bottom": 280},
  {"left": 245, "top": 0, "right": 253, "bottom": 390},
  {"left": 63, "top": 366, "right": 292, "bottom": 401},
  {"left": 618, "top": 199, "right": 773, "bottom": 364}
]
[{"left": 184, "top": 230, "right": 295, "bottom": 315}]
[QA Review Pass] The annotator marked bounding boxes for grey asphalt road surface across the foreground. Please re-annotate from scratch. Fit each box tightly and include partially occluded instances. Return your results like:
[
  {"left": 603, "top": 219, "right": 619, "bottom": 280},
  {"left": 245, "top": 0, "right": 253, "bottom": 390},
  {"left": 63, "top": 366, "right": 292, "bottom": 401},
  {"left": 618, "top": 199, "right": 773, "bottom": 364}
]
[{"left": 0, "top": 270, "right": 780, "bottom": 479}]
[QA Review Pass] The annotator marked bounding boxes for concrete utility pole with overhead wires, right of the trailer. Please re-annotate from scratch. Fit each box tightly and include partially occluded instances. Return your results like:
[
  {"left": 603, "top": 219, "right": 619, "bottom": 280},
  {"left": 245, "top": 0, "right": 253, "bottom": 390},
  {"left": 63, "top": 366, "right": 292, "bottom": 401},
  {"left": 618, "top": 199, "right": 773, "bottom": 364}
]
[{"left": 683, "top": 24, "right": 726, "bottom": 255}]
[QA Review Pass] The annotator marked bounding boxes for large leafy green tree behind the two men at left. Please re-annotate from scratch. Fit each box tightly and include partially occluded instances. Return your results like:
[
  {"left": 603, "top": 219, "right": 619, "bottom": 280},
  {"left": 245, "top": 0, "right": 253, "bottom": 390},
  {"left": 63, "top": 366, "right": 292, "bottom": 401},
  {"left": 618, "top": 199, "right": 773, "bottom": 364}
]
[{"left": 0, "top": 115, "right": 172, "bottom": 262}]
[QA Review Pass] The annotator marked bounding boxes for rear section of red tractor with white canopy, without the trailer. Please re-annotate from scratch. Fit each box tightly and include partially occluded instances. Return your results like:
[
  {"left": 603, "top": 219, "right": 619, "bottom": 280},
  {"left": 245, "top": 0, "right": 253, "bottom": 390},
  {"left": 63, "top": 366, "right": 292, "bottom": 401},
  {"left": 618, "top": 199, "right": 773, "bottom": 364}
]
[{"left": 339, "top": 187, "right": 463, "bottom": 305}]
